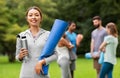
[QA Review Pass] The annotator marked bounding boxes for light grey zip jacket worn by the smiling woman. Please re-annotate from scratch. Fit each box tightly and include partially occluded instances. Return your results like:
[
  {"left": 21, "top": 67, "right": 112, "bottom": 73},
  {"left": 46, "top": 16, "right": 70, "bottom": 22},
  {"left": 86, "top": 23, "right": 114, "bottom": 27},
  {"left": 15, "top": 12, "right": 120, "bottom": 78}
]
[{"left": 16, "top": 29, "right": 57, "bottom": 78}]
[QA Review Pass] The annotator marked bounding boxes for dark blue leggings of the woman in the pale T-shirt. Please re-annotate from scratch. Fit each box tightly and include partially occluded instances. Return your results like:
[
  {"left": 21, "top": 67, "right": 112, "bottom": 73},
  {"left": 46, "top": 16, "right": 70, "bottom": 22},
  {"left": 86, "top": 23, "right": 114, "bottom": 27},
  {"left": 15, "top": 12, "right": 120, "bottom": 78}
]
[{"left": 100, "top": 62, "right": 114, "bottom": 78}]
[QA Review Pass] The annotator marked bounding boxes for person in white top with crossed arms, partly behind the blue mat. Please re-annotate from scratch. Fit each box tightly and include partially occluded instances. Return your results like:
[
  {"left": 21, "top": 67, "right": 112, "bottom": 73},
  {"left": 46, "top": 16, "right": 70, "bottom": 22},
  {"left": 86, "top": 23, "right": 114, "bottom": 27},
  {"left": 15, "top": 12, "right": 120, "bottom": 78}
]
[{"left": 56, "top": 34, "right": 74, "bottom": 78}]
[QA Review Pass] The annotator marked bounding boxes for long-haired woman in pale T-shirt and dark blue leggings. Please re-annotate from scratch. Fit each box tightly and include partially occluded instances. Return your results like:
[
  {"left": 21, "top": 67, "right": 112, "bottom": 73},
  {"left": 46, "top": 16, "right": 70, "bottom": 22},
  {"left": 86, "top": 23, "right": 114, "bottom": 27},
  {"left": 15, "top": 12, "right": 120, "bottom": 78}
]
[{"left": 99, "top": 22, "right": 118, "bottom": 78}]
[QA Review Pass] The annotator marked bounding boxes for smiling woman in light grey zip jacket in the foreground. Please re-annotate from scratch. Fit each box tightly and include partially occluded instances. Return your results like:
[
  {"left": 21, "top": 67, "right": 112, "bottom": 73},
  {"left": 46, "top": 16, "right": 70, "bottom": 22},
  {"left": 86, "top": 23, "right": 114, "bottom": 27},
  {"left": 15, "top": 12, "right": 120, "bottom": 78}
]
[{"left": 16, "top": 6, "right": 57, "bottom": 78}]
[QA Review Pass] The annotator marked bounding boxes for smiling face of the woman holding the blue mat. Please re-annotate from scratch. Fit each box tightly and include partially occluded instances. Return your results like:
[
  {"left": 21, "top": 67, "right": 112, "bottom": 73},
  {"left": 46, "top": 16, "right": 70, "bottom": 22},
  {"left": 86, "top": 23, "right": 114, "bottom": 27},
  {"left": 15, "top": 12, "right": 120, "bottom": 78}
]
[{"left": 27, "top": 9, "right": 42, "bottom": 27}]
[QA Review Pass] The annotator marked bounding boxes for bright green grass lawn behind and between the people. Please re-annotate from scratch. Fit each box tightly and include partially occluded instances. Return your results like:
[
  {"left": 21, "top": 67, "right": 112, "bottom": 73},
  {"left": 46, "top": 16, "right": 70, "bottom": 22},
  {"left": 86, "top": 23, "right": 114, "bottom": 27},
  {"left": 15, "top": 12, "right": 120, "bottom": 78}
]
[{"left": 0, "top": 56, "right": 120, "bottom": 78}]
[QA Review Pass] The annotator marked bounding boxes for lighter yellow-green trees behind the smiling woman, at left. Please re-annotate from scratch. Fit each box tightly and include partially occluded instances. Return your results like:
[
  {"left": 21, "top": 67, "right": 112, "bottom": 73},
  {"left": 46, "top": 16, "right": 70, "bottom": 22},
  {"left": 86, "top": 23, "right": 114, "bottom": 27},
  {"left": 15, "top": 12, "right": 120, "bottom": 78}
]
[{"left": 0, "top": 0, "right": 56, "bottom": 62}]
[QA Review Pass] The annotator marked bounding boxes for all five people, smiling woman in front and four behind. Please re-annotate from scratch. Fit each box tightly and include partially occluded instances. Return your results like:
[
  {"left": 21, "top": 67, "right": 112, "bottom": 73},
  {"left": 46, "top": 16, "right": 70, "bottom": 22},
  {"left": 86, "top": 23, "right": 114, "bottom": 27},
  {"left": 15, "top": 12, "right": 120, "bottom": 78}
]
[{"left": 16, "top": 6, "right": 118, "bottom": 78}]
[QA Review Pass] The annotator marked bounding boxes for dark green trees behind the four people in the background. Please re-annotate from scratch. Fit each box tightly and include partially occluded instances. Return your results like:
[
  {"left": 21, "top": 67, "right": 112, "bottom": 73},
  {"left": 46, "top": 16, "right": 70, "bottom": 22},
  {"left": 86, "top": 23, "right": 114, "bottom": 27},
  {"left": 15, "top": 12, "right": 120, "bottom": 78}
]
[{"left": 53, "top": 0, "right": 120, "bottom": 55}]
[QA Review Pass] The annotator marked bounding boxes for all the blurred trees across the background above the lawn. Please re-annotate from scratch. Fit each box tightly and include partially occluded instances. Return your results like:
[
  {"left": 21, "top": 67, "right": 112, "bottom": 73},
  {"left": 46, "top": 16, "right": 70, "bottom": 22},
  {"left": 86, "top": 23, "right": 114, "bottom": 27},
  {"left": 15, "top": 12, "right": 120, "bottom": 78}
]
[{"left": 0, "top": 0, "right": 120, "bottom": 62}]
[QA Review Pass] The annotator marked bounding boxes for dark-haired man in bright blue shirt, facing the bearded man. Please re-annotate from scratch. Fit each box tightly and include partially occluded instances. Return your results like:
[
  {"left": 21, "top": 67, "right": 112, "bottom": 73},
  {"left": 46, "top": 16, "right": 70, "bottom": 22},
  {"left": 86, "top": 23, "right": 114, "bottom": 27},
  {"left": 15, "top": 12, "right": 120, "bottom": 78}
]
[{"left": 65, "top": 22, "right": 83, "bottom": 78}]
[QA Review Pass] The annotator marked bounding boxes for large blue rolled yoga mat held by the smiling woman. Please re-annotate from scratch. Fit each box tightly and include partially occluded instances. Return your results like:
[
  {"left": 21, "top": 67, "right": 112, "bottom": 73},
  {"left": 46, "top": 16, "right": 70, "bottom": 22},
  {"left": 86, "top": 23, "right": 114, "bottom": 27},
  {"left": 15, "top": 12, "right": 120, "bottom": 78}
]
[{"left": 39, "top": 19, "right": 68, "bottom": 75}]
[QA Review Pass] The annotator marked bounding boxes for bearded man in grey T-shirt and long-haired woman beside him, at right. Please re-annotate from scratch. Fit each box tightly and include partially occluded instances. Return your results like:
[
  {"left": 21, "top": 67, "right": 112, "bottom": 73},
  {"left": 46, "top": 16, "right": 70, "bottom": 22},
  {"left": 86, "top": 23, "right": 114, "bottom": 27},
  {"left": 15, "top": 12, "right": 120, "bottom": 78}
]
[{"left": 90, "top": 16, "right": 118, "bottom": 78}]
